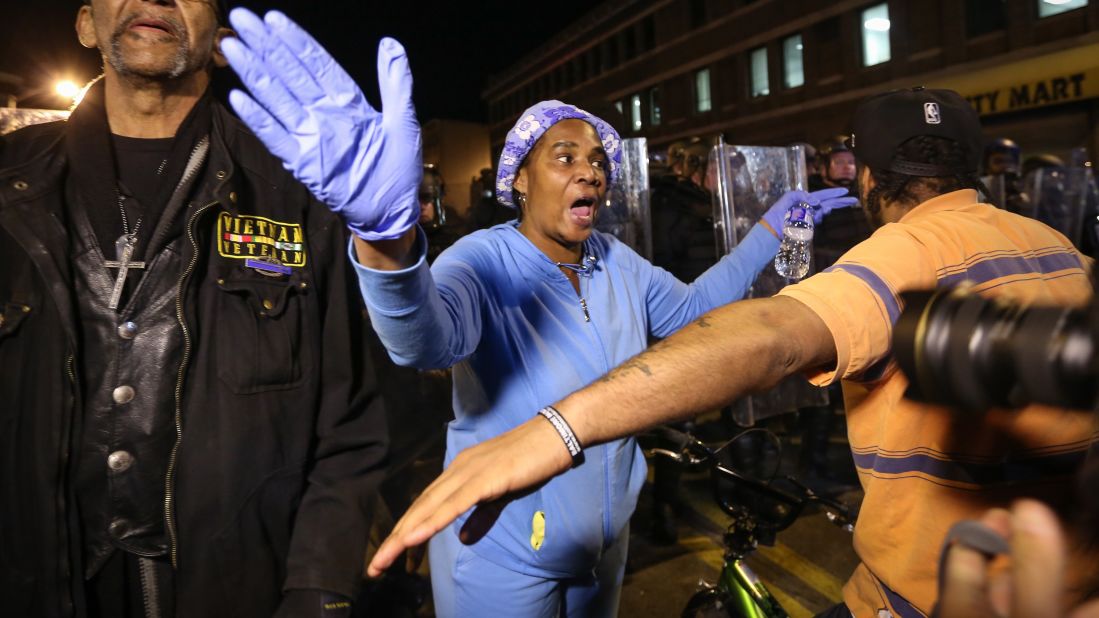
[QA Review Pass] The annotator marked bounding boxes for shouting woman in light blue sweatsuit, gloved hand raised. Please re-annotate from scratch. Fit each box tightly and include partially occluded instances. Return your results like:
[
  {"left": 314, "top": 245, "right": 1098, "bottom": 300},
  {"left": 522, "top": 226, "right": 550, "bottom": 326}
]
[{"left": 218, "top": 10, "right": 854, "bottom": 617}]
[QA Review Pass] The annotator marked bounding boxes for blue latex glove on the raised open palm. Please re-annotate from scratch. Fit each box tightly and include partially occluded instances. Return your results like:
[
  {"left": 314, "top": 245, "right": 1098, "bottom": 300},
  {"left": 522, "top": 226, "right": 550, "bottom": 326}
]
[{"left": 221, "top": 9, "right": 423, "bottom": 241}]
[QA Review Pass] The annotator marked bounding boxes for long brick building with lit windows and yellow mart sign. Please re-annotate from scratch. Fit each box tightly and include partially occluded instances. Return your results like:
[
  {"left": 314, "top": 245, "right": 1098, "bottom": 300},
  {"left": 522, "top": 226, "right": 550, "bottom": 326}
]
[{"left": 484, "top": 0, "right": 1099, "bottom": 159}]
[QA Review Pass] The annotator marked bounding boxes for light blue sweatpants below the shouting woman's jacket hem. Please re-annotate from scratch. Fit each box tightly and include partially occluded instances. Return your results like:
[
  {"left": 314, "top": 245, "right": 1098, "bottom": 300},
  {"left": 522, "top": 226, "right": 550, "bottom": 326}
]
[{"left": 428, "top": 525, "right": 630, "bottom": 618}]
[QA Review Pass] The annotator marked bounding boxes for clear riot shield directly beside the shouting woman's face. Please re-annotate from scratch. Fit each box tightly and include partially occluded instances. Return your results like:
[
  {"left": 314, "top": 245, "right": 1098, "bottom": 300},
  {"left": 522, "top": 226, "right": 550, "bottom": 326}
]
[{"left": 596, "top": 137, "right": 653, "bottom": 262}]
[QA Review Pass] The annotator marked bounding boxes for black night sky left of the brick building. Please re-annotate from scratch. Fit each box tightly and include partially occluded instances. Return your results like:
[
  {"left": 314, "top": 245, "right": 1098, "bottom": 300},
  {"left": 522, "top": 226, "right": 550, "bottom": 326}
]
[{"left": 0, "top": 0, "right": 593, "bottom": 121}]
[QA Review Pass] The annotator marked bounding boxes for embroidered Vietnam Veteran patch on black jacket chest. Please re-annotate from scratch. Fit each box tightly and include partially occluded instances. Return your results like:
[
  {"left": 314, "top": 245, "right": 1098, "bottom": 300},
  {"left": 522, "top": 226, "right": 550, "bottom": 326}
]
[{"left": 218, "top": 212, "right": 306, "bottom": 267}]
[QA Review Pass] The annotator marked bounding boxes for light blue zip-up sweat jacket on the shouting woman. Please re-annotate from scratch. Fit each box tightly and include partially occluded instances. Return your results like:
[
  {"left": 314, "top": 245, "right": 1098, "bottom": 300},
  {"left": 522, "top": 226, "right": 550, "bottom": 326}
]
[{"left": 352, "top": 221, "right": 778, "bottom": 611}]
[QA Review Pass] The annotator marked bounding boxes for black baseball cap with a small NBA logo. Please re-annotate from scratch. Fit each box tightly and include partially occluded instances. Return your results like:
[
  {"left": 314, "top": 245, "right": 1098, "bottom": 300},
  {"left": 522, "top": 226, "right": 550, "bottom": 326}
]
[{"left": 850, "top": 86, "right": 985, "bottom": 176}]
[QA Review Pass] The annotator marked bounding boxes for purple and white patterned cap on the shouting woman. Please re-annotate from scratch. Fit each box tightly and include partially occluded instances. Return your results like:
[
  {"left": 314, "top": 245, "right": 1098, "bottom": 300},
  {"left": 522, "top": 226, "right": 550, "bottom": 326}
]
[{"left": 496, "top": 100, "right": 622, "bottom": 208}]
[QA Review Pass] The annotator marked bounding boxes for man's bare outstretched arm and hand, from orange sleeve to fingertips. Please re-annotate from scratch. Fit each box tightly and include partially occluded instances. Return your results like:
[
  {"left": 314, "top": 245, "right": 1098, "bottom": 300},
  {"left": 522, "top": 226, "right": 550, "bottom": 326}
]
[{"left": 368, "top": 297, "right": 835, "bottom": 576}]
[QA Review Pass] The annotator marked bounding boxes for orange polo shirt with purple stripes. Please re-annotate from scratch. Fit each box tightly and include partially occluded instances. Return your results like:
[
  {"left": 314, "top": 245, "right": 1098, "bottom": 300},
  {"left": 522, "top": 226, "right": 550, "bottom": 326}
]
[{"left": 779, "top": 189, "right": 1097, "bottom": 618}]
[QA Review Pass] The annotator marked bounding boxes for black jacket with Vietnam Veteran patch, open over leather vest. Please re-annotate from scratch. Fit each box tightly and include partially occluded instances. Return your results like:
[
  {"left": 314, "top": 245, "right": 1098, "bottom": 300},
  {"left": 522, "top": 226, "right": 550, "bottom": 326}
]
[{"left": 0, "top": 100, "right": 386, "bottom": 618}]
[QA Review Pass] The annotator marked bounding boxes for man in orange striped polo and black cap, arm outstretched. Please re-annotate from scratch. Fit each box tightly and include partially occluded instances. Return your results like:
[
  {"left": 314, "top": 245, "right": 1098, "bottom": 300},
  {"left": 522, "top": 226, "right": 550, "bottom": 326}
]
[{"left": 371, "top": 88, "right": 1099, "bottom": 618}]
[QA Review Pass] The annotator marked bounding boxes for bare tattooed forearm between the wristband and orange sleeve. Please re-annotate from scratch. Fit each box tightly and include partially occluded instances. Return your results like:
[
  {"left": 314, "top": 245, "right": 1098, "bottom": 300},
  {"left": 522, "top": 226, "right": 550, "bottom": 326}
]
[{"left": 556, "top": 297, "right": 835, "bottom": 445}]
